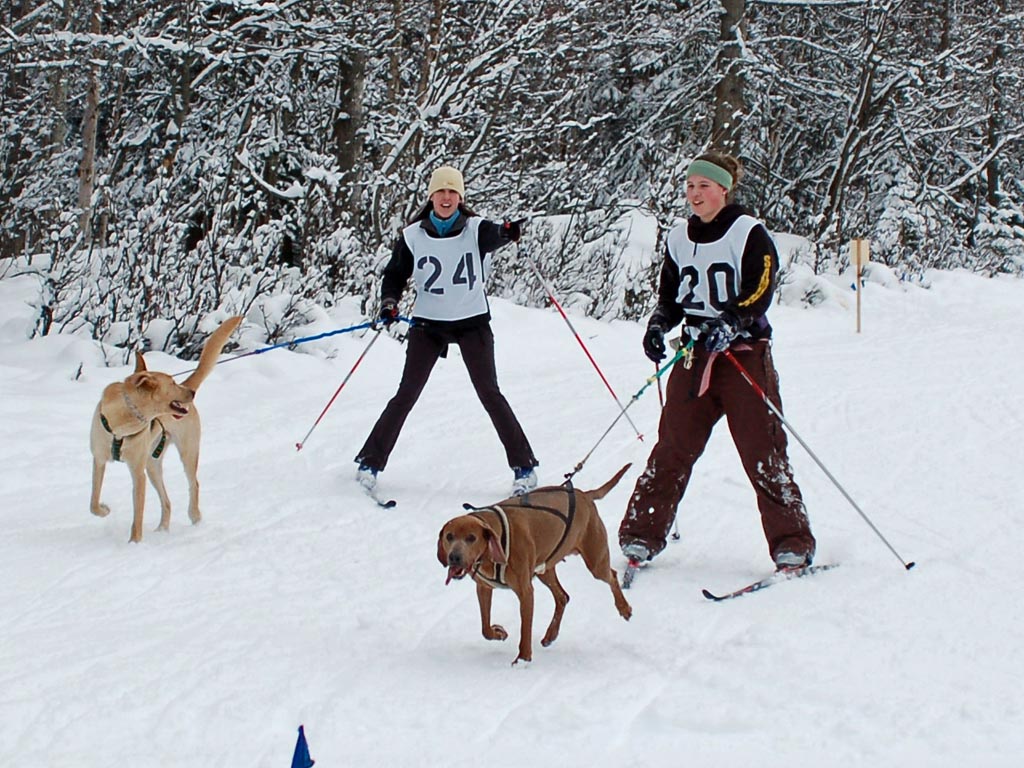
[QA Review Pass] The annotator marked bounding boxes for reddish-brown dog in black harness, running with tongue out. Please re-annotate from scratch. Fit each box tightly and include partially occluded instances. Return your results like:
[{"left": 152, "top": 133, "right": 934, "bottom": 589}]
[{"left": 437, "top": 464, "right": 633, "bottom": 664}]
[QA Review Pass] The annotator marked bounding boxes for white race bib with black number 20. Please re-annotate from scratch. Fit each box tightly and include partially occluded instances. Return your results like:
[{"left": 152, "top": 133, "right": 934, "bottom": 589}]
[{"left": 669, "top": 214, "right": 761, "bottom": 317}]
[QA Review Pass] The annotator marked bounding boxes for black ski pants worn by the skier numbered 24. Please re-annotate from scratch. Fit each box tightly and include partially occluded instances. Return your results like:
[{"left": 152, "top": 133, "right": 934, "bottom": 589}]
[{"left": 355, "top": 325, "right": 538, "bottom": 469}]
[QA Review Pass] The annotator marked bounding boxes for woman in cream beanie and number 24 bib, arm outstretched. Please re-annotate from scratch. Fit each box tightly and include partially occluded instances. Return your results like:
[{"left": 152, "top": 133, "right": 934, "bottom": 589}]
[{"left": 355, "top": 166, "right": 538, "bottom": 494}]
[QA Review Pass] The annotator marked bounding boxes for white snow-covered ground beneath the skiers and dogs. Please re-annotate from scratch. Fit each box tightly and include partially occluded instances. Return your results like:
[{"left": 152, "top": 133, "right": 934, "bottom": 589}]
[{"left": 0, "top": 273, "right": 1024, "bottom": 768}]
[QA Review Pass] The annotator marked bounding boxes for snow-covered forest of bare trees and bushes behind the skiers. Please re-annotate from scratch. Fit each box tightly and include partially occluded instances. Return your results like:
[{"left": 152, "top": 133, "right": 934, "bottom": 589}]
[{"left": 0, "top": 0, "right": 1024, "bottom": 352}]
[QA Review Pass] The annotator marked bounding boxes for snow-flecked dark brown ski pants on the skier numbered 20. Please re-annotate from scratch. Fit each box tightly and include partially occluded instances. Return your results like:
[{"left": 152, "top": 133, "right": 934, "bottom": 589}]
[{"left": 618, "top": 341, "right": 815, "bottom": 557}]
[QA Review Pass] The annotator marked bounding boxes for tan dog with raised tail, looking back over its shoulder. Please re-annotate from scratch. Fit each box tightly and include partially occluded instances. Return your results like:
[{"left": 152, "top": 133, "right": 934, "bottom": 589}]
[{"left": 89, "top": 316, "right": 242, "bottom": 542}]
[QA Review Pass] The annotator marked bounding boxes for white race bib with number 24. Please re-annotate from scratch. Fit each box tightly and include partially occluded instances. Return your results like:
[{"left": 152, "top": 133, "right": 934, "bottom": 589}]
[{"left": 401, "top": 216, "right": 490, "bottom": 321}]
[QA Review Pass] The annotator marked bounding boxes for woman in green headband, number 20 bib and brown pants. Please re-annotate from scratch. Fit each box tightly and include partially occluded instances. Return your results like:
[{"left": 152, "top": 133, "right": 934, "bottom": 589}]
[{"left": 618, "top": 153, "right": 815, "bottom": 569}]
